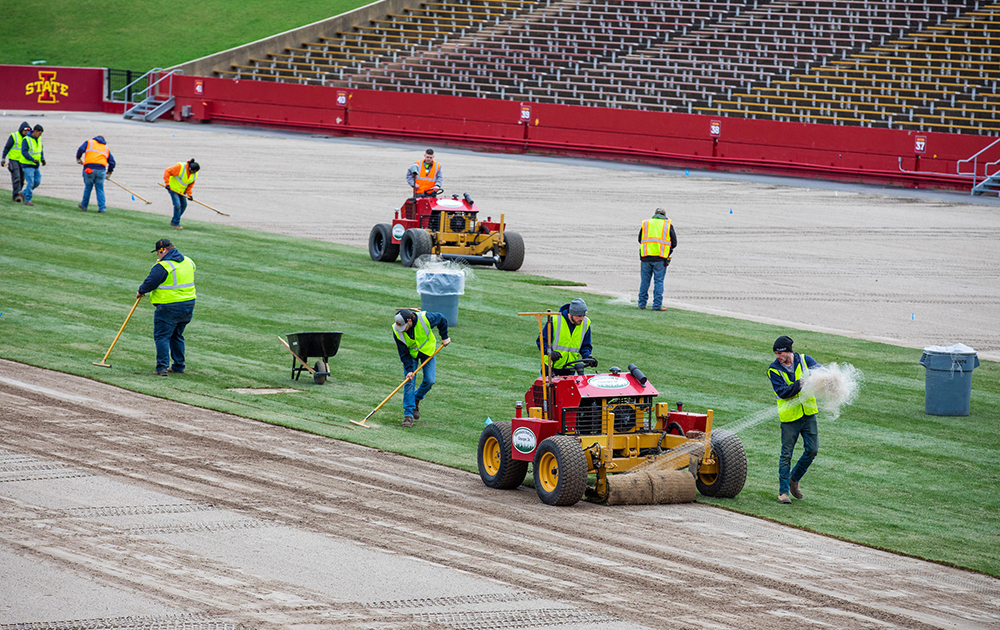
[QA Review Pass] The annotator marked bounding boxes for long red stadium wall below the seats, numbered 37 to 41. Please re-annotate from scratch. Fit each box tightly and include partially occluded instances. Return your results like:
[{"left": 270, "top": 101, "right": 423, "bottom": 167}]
[{"left": 168, "top": 77, "right": 988, "bottom": 190}]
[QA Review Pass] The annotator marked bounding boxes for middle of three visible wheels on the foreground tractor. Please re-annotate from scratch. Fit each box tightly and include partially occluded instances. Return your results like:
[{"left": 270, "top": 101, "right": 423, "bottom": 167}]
[{"left": 532, "top": 435, "right": 587, "bottom": 505}]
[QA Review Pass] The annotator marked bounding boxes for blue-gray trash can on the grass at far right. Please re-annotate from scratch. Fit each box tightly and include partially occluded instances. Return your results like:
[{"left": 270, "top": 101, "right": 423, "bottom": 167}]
[{"left": 920, "top": 343, "right": 979, "bottom": 416}]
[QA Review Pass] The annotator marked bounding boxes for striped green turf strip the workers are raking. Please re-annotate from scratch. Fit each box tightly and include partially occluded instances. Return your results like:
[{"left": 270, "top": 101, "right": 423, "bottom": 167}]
[{"left": 0, "top": 196, "right": 1000, "bottom": 575}]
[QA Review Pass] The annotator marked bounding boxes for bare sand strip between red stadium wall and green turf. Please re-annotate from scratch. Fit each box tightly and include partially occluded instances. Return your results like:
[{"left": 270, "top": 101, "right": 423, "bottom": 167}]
[{"left": 0, "top": 112, "right": 1000, "bottom": 361}]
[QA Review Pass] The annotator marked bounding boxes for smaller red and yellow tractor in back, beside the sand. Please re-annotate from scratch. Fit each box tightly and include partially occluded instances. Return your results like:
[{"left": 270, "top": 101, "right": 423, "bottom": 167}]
[{"left": 368, "top": 193, "right": 524, "bottom": 271}]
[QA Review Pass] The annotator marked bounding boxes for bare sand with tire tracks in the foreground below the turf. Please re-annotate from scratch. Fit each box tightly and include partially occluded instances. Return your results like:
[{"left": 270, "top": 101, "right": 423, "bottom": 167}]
[{"left": 0, "top": 360, "right": 1000, "bottom": 630}]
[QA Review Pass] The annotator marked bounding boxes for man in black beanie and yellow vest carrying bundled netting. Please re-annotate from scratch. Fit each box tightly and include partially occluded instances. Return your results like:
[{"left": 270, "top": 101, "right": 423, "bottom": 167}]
[{"left": 767, "top": 335, "right": 822, "bottom": 503}]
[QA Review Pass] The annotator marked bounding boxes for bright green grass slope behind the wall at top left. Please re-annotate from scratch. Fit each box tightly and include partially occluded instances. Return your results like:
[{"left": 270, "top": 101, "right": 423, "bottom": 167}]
[{"left": 0, "top": 0, "right": 367, "bottom": 72}]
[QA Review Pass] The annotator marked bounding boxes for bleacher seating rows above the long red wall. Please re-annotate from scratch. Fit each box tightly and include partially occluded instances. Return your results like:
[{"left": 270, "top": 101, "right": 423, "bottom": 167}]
[{"left": 216, "top": 0, "right": 1000, "bottom": 134}]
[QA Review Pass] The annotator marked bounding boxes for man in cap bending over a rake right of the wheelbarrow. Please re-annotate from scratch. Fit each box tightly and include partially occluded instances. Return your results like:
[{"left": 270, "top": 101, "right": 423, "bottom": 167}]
[{"left": 392, "top": 309, "right": 451, "bottom": 427}]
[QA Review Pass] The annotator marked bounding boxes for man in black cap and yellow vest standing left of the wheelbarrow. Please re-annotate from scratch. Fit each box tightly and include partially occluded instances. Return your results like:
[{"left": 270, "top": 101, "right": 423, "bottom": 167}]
[{"left": 136, "top": 238, "right": 196, "bottom": 376}]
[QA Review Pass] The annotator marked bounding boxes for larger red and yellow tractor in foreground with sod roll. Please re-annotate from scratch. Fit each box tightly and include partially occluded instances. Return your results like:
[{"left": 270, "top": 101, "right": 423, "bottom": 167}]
[{"left": 477, "top": 311, "right": 747, "bottom": 505}]
